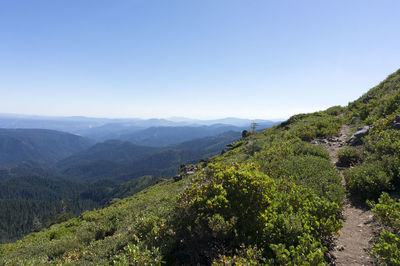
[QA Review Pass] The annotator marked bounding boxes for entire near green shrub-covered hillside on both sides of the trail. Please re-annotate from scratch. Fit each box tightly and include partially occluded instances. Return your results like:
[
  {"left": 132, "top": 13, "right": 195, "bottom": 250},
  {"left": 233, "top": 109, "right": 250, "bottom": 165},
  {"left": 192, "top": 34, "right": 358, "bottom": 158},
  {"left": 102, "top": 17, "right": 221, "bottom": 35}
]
[{"left": 0, "top": 70, "right": 400, "bottom": 265}]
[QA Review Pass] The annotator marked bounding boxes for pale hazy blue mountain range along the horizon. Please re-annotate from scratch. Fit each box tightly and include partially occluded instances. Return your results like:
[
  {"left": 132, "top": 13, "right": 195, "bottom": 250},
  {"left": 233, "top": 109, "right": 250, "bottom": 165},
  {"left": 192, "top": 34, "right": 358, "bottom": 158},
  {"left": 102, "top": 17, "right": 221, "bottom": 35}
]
[{"left": 0, "top": 114, "right": 278, "bottom": 141}]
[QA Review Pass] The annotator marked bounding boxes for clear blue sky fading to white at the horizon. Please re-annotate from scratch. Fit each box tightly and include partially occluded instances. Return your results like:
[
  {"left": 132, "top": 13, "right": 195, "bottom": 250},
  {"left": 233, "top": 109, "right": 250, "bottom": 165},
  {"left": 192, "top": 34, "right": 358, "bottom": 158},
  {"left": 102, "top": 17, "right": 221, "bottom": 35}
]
[{"left": 0, "top": 0, "right": 400, "bottom": 118}]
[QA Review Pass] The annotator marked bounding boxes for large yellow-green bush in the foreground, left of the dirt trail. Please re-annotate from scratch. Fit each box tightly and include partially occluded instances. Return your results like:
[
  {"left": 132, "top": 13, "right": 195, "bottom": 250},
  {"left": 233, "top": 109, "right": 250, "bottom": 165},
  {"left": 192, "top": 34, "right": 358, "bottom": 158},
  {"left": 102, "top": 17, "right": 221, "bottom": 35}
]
[{"left": 175, "top": 164, "right": 341, "bottom": 264}]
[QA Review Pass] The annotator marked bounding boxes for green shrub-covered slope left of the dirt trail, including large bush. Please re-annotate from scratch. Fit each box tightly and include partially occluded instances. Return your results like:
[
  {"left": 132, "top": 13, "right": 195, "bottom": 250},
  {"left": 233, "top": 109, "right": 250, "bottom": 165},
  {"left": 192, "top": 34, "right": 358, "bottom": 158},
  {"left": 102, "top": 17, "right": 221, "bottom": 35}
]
[{"left": 0, "top": 101, "right": 344, "bottom": 264}]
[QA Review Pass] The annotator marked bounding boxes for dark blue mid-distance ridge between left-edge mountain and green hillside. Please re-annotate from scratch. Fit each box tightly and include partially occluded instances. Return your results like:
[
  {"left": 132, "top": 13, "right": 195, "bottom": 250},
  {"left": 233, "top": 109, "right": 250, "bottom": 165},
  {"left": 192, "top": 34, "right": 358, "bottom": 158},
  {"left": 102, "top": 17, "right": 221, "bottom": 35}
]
[{"left": 57, "top": 132, "right": 240, "bottom": 181}]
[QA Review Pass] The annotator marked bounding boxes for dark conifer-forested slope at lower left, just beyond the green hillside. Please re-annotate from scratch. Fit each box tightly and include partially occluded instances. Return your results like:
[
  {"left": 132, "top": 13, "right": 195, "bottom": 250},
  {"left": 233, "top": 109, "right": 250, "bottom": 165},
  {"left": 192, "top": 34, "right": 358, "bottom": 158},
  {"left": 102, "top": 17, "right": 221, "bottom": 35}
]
[{"left": 0, "top": 172, "right": 170, "bottom": 243}]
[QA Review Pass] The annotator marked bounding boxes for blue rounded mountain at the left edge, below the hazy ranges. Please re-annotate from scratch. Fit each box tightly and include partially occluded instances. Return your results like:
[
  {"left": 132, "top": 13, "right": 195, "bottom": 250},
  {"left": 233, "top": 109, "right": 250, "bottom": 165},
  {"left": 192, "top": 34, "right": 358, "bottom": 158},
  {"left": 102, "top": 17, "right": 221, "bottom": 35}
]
[{"left": 0, "top": 129, "right": 92, "bottom": 166}]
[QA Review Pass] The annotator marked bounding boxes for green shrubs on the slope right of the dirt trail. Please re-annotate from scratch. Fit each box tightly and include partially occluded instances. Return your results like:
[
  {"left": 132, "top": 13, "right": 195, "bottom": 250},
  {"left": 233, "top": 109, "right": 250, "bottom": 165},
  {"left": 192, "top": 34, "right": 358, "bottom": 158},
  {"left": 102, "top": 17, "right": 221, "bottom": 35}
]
[{"left": 345, "top": 70, "right": 400, "bottom": 265}]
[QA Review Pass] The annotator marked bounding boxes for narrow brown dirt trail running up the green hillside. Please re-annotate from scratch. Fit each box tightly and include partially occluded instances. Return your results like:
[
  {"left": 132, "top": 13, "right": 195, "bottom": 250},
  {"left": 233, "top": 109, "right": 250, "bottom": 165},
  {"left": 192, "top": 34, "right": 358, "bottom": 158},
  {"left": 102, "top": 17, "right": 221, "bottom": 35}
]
[{"left": 313, "top": 125, "right": 376, "bottom": 265}]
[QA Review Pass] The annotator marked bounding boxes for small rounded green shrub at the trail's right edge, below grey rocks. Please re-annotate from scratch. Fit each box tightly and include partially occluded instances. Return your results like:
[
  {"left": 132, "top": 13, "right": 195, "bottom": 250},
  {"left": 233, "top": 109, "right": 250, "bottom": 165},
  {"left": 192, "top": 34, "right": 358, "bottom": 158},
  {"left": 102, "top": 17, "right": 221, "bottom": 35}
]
[{"left": 344, "top": 161, "right": 394, "bottom": 198}]
